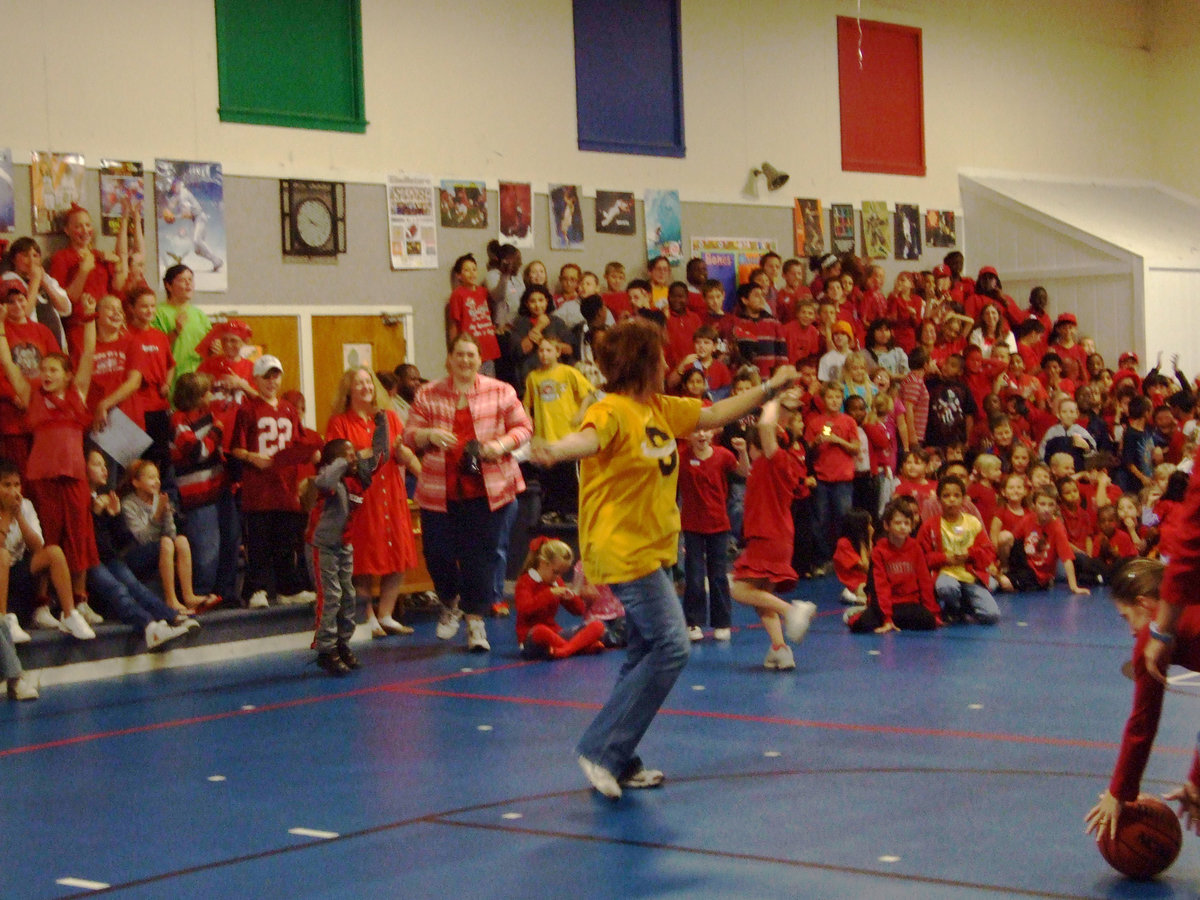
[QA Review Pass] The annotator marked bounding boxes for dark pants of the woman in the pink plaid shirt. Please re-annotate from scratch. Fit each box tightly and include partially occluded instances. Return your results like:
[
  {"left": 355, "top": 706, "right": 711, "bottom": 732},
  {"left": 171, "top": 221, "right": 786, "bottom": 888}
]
[{"left": 421, "top": 497, "right": 517, "bottom": 616}]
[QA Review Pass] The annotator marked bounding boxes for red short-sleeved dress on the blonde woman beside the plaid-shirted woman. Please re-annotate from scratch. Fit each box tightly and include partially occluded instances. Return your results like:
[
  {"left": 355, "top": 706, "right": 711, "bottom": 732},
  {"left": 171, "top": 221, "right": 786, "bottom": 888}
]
[{"left": 325, "top": 409, "right": 416, "bottom": 575}]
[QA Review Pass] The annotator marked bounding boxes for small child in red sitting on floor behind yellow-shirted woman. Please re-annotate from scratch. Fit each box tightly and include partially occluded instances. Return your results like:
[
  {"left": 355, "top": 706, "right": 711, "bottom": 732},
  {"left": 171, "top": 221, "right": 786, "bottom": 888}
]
[{"left": 512, "top": 536, "right": 604, "bottom": 660}]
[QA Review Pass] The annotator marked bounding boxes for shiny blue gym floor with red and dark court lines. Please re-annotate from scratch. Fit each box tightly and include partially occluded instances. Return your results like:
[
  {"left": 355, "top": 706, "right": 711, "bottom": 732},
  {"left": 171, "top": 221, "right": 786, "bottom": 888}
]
[{"left": 0, "top": 578, "right": 1200, "bottom": 900}]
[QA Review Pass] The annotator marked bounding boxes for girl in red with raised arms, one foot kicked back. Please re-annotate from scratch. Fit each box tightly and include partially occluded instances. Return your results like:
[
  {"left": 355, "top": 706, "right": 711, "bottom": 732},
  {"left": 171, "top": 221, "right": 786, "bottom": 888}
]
[{"left": 731, "top": 398, "right": 817, "bottom": 670}]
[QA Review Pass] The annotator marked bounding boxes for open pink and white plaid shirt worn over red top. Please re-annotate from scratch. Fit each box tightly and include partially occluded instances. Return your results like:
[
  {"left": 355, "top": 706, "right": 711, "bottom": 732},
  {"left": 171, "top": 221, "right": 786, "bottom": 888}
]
[{"left": 404, "top": 374, "right": 533, "bottom": 512}]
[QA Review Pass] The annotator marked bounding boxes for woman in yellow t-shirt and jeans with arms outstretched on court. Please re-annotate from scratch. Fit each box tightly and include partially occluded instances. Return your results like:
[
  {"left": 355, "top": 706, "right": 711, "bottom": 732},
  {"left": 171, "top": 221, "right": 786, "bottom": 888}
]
[{"left": 533, "top": 319, "right": 796, "bottom": 799}]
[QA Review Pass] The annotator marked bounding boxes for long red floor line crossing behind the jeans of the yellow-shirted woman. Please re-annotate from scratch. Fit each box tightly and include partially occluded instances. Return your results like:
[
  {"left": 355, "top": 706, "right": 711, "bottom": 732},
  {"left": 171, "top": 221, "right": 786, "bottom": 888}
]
[{"left": 390, "top": 685, "right": 1192, "bottom": 756}]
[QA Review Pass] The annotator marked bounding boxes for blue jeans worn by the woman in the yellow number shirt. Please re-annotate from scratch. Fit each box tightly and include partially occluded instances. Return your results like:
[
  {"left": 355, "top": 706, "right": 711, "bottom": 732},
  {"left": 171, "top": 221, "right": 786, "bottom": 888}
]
[{"left": 576, "top": 569, "right": 691, "bottom": 778}]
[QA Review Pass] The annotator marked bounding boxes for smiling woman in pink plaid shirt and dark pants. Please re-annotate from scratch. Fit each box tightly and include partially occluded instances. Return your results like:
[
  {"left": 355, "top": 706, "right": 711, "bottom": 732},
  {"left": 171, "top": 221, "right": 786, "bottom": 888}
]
[{"left": 404, "top": 332, "right": 533, "bottom": 652}]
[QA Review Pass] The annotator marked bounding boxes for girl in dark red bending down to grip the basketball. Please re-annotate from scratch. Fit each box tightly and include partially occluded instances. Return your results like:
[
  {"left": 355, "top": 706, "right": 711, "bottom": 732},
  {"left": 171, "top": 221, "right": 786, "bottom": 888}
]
[{"left": 1084, "top": 559, "right": 1200, "bottom": 840}]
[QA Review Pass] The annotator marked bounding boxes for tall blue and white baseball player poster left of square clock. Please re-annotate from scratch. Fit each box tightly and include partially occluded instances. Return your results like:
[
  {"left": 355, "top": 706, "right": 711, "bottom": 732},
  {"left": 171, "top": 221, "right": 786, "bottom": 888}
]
[{"left": 154, "top": 160, "right": 229, "bottom": 290}]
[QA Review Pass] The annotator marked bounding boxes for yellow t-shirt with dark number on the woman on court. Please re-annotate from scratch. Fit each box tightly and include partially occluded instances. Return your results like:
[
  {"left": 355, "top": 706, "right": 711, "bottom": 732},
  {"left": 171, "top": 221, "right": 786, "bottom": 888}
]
[{"left": 580, "top": 394, "right": 701, "bottom": 584}]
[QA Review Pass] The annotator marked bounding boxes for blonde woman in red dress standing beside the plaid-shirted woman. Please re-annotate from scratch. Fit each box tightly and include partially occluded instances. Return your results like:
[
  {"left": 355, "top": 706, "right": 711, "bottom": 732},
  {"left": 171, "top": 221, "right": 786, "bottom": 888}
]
[{"left": 325, "top": 366, "right": 420, "bottom": 637}]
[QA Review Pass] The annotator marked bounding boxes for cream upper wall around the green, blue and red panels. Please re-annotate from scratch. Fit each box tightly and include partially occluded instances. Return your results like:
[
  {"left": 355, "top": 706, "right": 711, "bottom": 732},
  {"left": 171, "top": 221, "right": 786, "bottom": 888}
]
[{"left": 0, "top": 0, "right": 1161, "bottom": 206}]
